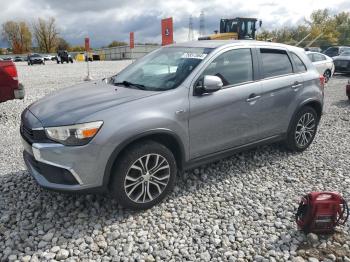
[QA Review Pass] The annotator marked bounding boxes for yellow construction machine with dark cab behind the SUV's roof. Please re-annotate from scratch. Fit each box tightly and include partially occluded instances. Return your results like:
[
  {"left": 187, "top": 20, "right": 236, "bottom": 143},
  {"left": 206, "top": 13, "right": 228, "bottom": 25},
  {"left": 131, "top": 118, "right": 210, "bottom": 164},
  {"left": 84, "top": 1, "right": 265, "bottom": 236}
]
[{"left": 198, "top": 17, "right": 262, "bottom": 40}]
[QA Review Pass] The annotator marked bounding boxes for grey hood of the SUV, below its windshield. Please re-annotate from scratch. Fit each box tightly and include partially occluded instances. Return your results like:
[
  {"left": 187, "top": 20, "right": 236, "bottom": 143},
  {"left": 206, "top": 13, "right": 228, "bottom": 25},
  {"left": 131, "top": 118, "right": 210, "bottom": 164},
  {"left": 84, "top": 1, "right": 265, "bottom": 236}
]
[{"left": 29, "top": 81, "right": 159, "bottom": 127}]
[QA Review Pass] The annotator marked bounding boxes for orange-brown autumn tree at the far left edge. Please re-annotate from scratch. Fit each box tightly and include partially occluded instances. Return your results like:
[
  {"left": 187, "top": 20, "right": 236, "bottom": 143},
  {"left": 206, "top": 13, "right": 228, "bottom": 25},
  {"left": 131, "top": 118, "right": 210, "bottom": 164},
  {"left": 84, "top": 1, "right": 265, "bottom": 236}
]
[{"left": 2, "top": 21, "right": 32, "bottom": 54}]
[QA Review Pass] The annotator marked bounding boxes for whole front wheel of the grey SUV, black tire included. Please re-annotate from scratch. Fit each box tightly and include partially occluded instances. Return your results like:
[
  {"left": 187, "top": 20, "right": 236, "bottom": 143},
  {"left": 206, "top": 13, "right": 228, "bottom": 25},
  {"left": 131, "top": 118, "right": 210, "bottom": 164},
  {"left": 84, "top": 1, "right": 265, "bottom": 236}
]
[{"left": 110, "top": 141, "right": 177, "bottom": 210}]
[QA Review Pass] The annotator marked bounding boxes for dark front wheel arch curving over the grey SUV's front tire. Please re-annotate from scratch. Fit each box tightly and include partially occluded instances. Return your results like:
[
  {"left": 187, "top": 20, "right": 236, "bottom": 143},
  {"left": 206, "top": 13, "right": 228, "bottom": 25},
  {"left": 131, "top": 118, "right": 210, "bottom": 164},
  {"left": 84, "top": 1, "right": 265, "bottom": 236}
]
[{"left": 103, "top": 129, "right": 185, "bottom": 188}]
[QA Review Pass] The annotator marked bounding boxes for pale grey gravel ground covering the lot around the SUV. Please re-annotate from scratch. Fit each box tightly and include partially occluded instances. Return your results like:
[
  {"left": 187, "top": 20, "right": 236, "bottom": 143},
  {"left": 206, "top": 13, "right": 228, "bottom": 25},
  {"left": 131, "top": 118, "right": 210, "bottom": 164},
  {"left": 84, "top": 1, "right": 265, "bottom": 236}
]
[{"left": 0, "top": 62, "right": 350, "bottom": 261}]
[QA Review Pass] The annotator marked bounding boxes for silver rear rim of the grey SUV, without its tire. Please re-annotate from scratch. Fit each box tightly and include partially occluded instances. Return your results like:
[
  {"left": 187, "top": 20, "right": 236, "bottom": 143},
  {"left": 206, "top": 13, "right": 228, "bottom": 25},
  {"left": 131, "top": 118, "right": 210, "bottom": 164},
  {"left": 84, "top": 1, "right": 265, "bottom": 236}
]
[{"left": 295, "top": 113, "right": 316, "bottom": 148}]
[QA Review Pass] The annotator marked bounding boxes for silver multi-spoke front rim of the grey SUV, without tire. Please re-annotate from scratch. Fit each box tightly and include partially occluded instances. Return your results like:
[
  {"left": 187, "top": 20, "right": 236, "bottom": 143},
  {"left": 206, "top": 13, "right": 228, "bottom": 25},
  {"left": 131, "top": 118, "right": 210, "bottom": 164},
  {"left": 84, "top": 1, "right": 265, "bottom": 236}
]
[{"left": 124, "top": 154, "right": 170, "bottom": 203}]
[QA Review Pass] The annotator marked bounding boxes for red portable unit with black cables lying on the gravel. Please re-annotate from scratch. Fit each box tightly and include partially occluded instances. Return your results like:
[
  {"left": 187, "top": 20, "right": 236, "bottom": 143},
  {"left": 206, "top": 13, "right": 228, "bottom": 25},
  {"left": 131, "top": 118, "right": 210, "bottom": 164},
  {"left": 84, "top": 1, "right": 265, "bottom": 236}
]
[{"left": 296, "top": 192, "right": 349, "bottom": 234}]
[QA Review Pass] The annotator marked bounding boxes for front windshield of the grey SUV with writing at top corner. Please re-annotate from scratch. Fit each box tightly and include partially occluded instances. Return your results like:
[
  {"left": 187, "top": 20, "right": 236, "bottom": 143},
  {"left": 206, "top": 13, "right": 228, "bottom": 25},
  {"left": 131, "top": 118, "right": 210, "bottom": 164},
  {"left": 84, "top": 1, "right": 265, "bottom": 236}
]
[{"left": 113, "top": 47, "right": 212, "bottom": 91}]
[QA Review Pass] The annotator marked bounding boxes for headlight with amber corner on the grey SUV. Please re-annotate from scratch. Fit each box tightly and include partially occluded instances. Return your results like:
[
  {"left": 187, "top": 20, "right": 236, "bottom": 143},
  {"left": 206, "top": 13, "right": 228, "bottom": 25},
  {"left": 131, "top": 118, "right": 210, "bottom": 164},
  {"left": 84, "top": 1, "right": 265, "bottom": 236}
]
[{"left": 45, "top": 121, "right": 103, "bottom": 146}]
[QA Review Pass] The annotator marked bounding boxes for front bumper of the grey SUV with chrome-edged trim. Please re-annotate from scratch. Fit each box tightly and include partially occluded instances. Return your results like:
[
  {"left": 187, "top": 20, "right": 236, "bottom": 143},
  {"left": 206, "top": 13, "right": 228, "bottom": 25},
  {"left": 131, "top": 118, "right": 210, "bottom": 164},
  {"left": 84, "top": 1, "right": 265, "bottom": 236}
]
[{"left": 22, "top": 137, "right": 103, "bottom": 192}]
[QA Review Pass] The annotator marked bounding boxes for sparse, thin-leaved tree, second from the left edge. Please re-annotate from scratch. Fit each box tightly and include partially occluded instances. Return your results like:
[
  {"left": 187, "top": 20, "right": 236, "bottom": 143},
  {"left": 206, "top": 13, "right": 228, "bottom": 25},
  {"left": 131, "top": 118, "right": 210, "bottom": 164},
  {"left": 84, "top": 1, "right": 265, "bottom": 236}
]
[{"left": 33, "top": 17, "right": 58, "bottom": 53}]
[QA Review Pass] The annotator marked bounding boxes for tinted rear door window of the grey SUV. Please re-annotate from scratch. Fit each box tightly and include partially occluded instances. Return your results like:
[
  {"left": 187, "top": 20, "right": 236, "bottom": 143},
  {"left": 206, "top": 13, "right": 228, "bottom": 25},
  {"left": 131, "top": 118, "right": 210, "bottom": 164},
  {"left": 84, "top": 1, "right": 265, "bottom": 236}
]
[{"left": 260, "top": 48, "right": 293, "bottom": 78}]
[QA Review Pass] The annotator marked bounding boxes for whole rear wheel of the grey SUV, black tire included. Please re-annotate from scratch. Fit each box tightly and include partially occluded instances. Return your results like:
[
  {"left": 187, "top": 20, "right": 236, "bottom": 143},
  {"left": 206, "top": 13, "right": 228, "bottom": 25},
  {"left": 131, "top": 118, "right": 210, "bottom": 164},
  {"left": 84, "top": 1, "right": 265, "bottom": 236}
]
[{"left": 285, "top": 106, "right": 319, "bottom": 152}]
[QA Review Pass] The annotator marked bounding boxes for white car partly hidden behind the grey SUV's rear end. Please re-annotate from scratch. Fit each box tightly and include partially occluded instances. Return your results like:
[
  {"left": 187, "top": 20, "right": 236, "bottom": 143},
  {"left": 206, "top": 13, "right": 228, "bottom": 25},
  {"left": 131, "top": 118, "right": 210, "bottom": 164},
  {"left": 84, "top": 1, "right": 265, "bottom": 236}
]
[{"left": 306, "top": 52, "right": 334, "bottom": 83}]
